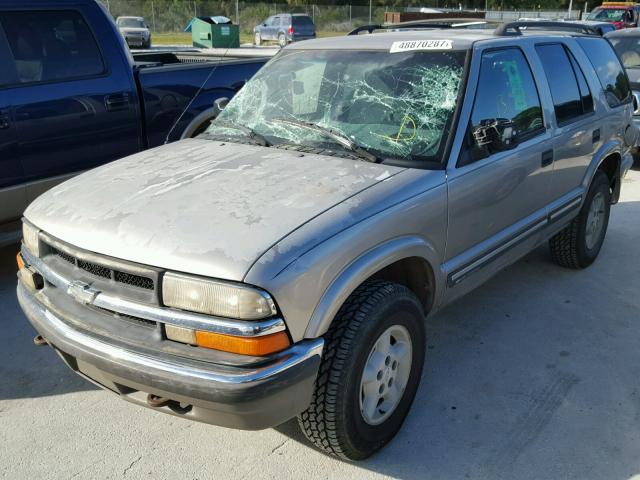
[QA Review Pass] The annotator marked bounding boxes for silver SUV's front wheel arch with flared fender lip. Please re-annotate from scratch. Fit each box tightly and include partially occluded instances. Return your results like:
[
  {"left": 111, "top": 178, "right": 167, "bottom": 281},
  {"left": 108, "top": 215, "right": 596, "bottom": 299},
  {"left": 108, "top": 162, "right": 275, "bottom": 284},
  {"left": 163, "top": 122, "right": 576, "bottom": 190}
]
[{"left": 304, "top": 236, "right": 440, "bottom": 338}]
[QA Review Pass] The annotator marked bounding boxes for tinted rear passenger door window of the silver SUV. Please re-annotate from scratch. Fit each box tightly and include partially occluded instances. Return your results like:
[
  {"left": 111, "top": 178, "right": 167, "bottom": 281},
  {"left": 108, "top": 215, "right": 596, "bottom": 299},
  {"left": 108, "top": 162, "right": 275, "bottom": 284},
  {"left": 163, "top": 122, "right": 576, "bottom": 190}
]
[{"left": 536, "top": 43, "right": 593, "bottom": 124}]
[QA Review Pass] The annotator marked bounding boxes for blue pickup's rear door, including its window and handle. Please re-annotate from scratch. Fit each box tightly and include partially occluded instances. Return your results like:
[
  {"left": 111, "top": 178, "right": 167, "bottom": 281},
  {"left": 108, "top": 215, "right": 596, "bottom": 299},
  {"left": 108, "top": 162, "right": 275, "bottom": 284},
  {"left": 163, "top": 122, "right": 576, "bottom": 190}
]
[{"left": 0, "top": 3, "right": 140, "bottom": 197}]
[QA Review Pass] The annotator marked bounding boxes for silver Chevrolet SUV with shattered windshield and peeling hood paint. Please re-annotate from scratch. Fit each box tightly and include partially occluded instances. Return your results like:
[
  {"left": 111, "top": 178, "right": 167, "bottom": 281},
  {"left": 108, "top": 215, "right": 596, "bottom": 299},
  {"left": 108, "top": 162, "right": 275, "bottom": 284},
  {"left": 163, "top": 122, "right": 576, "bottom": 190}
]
[{"left": 18, "top": 24, "right": 636, "bottom": 459}]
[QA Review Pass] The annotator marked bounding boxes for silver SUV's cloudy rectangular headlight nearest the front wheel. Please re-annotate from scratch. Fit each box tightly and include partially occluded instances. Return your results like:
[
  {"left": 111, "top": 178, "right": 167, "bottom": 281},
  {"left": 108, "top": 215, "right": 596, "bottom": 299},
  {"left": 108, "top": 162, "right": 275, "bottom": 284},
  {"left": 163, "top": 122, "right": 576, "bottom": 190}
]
[{"left": 162, "top": 273, "right": 277, "bottom": 320}]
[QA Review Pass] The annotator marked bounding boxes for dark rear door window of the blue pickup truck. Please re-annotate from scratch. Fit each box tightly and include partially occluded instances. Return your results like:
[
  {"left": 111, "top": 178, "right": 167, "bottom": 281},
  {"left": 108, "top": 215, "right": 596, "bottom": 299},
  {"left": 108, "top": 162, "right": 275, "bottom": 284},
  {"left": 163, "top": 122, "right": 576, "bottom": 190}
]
[{"left": 0, "top": 10, "right": 105, "bottom": 84}]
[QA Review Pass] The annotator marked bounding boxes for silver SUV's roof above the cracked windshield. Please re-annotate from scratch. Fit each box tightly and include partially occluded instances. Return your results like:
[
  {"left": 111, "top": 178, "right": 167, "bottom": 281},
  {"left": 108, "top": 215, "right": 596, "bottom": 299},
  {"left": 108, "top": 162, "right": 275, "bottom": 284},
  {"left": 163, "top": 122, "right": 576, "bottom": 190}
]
[{"left": 287, "top": 28, "right": 604, "bottom": 50}]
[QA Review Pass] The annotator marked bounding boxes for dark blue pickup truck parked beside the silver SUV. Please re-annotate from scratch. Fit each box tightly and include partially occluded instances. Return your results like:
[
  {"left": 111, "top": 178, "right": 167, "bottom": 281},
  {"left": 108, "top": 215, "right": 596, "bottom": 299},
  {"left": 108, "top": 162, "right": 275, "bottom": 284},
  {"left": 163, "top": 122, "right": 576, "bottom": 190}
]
[{"left": 0, "top": 0, "right": 269, "bottom": 240}]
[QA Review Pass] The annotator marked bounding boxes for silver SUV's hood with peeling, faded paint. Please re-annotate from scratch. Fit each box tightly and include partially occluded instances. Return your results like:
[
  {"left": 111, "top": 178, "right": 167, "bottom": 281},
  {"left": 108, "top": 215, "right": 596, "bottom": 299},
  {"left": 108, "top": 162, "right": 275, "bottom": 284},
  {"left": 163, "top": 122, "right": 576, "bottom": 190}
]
[{"left": 25, "top": 139, "right": 404, "bottom": 281}]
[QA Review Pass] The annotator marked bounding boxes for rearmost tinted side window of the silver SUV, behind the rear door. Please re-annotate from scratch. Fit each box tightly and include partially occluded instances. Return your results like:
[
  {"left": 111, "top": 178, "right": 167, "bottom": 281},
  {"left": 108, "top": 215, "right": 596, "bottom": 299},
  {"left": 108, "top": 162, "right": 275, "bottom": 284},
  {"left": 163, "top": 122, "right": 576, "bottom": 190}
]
[{"left": 576, "top": 37, "right": 631, "bottom": 107}]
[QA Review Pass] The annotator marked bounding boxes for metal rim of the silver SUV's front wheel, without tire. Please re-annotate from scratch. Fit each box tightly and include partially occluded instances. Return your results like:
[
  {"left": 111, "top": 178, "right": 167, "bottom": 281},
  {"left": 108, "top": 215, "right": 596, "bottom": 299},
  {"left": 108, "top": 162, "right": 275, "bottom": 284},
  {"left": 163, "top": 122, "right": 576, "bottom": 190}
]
[{"left": 360, "top": 325, "right": 413, "bottom": 425}]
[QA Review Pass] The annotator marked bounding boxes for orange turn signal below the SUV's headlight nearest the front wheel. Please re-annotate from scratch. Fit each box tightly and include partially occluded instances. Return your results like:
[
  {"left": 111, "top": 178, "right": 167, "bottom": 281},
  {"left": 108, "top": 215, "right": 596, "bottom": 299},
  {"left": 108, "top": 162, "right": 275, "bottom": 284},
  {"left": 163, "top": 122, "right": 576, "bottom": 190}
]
[{"left": 196, "top": 330, "right": 290, "bottom": 357}]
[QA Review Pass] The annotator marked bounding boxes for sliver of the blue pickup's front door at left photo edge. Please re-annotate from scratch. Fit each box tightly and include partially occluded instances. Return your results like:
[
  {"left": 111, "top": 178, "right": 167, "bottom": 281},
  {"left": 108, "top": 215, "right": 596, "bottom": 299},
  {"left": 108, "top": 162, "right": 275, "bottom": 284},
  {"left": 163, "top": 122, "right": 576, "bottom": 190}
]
[{"left": 0, "top": 23, "right": 27, "bottom": 224}]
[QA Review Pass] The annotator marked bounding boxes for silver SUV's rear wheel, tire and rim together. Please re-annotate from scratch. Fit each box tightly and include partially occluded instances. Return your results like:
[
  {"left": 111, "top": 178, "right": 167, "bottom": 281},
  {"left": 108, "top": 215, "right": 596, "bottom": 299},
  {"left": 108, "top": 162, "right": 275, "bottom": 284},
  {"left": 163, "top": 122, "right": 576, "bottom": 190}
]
[{"left": 549, "top": 171, "right": 611, "bottom": 269}]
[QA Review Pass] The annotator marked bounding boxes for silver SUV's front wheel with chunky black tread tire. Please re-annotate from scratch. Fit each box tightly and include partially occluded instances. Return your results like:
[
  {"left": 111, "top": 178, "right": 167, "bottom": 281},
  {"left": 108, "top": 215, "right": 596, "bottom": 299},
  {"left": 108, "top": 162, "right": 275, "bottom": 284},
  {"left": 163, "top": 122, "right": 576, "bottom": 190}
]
[{"left": 298, "top": 280, "right": 426, "bottom": 460}]
